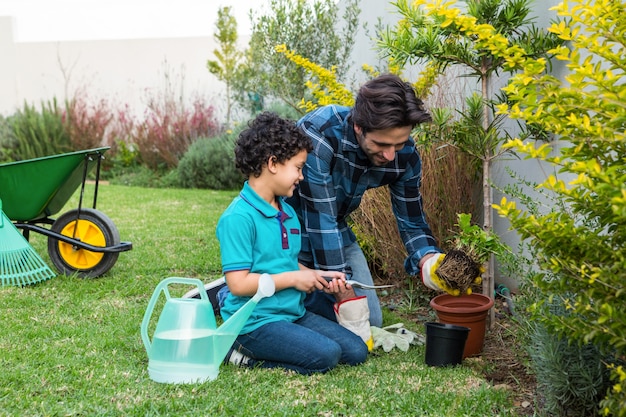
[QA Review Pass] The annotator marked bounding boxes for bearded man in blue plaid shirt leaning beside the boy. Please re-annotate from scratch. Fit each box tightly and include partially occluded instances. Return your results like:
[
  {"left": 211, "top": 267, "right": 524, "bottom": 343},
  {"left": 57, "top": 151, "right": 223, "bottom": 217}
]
[{"left": 287, "top": 74, "right": 441, "bottom": 327}]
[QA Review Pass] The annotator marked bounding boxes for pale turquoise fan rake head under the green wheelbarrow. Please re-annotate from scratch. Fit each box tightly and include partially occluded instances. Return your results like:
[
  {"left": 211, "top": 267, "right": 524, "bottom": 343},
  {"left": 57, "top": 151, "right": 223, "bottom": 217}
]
[{"left": 0, "top": 200, "right": 56, "bottom": 287}]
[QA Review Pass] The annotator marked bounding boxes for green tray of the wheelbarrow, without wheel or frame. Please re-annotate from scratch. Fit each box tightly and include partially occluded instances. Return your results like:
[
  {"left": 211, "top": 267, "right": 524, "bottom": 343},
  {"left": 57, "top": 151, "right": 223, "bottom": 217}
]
[{"left": 0, "top": 147, "right": 109, "bottom": 222}]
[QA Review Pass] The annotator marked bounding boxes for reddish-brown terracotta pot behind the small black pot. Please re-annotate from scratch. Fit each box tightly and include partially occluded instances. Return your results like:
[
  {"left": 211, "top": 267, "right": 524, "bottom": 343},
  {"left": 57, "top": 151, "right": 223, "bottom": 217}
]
[{"left": 430, "top": 294, "right": 493, "bottom": 358}]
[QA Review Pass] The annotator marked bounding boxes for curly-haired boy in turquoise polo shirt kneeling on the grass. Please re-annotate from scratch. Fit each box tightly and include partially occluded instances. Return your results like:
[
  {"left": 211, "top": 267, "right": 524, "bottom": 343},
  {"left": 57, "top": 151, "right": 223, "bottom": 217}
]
[{"left": 217, "top": 112, "right": 368, "bottom": 375}]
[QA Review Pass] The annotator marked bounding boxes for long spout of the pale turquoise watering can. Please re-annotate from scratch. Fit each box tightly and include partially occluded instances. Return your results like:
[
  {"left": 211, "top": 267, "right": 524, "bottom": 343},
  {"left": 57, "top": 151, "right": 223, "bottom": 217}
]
[{"left": 215, "top": 274, "right": 276, "bottom": 360}]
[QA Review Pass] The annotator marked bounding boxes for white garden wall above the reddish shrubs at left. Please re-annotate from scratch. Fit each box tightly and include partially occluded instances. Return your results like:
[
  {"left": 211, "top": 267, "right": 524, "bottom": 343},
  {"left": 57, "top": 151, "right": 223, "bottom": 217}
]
[{"left": 0, "top": 17, "right": 234, "bottom": 115}]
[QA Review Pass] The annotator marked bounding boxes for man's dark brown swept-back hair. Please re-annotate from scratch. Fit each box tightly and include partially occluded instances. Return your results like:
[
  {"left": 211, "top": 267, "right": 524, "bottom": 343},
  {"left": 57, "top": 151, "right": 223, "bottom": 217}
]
[{"left": 351, "top": 74, "right": 431, "bottom": 134}]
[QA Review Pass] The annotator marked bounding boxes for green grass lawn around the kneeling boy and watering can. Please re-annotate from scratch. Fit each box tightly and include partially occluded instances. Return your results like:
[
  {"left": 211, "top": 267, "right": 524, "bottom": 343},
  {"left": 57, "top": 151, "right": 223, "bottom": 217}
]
[{"left": 0, "top": 185, "right": 515, "bottom": 416}]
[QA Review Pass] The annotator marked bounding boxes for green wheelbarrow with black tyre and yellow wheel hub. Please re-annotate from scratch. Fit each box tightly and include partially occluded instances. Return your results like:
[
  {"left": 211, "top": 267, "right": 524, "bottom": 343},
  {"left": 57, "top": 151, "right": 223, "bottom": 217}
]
[{"left": 0, "top": 147, "right": 132, "bottom": 278}]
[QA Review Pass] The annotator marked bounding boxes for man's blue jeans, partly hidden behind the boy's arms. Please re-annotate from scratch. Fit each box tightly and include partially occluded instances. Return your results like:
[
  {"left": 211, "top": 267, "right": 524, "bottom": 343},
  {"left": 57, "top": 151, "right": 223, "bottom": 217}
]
[{"left": 299, "top": 243, "right": 383, "bottom": 327}]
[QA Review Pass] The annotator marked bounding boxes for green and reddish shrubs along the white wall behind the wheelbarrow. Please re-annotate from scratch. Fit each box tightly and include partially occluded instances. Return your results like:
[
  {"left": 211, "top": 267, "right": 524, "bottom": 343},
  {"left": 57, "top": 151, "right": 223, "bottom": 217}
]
[{"left": 0, "top": 86, "right": 221, "bottom": 186}]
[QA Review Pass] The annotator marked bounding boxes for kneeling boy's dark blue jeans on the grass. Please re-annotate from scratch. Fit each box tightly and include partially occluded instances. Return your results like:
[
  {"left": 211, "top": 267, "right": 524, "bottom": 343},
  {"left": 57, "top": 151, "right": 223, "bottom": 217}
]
[{"left": 233, "top": 311, "right": 367, "bottom": 375}]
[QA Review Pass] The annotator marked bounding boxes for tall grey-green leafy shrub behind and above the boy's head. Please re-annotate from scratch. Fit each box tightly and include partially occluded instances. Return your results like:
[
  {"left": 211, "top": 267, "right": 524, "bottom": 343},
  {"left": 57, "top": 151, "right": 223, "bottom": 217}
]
[{"left": 234, "top": 0, "right": 360, "bottom": 113}]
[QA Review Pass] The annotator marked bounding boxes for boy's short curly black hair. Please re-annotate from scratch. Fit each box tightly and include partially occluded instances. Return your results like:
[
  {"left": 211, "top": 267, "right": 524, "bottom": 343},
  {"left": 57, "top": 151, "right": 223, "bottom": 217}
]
[{"left": 235, "top": 112, "right": 313, "bottom": 178}]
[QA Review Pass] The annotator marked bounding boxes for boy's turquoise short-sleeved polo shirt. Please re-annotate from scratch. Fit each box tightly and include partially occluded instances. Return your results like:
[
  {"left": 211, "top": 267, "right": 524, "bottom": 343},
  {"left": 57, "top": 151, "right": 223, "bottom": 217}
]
[{"left": 217, "top": 181, "right": 306, "bottom": 334}]
